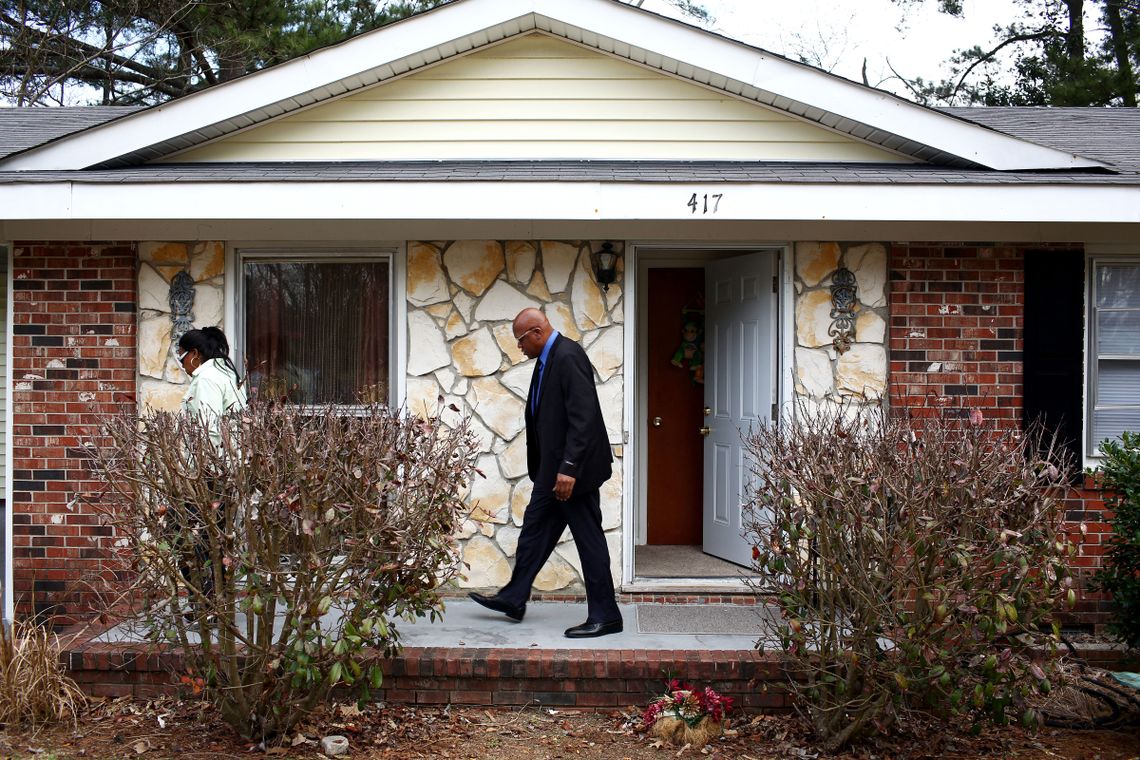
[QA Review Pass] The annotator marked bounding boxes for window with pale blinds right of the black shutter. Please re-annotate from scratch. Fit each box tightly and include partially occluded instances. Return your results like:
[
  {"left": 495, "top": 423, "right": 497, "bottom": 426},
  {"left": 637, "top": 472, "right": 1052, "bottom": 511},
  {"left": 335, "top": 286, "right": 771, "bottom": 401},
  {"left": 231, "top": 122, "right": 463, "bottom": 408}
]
[{"left": 1089, "top": 259, "right": 1140, "bottom": 451}]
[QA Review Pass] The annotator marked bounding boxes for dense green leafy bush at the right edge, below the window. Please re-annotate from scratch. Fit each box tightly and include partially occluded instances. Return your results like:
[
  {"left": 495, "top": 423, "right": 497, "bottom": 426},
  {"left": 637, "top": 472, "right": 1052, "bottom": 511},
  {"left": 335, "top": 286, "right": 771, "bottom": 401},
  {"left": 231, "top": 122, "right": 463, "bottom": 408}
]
[{"left": 1093, "top": 433, "right": 1140, "bottom": 647}]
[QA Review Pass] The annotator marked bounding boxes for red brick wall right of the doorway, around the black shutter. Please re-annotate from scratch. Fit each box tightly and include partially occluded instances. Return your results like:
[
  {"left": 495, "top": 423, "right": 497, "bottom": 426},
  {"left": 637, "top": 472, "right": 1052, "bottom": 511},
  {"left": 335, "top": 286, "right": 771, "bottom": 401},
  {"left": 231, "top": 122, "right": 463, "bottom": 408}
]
[{"left": 888, "top": 243, "right": 1112, "bottom": 626}]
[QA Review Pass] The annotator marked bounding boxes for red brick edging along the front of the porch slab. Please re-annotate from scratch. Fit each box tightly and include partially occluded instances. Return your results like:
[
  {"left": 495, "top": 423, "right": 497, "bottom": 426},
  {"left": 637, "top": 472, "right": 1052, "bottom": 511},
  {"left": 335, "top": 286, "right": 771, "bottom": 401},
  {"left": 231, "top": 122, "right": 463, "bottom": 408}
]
[{"left": 60, "top": 643, "right": 790, "bottom": 712}]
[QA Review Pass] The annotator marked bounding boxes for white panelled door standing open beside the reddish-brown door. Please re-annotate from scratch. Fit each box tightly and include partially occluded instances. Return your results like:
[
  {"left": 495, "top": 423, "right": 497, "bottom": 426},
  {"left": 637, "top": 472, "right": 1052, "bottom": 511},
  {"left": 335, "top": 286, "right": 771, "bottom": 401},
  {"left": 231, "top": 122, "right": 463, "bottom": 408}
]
[{"left": 703, "top": 251, "right": 776, "bottom": 565}]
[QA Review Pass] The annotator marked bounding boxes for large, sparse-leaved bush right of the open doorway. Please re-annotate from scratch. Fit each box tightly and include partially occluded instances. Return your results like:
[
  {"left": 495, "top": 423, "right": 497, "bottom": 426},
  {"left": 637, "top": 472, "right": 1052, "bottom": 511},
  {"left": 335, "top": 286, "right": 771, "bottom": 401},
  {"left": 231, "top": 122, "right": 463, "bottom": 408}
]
[{"left": 747, "top": 408, "right": 1075, "bottom": 751}]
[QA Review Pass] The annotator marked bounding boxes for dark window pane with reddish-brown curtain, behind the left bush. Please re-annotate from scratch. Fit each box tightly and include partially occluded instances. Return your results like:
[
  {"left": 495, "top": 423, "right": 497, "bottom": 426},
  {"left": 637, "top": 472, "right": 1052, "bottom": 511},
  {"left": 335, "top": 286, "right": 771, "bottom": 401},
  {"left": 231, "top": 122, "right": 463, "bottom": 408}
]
[{"left": 242, "top": 259, "right": 390, "bottom": 404}]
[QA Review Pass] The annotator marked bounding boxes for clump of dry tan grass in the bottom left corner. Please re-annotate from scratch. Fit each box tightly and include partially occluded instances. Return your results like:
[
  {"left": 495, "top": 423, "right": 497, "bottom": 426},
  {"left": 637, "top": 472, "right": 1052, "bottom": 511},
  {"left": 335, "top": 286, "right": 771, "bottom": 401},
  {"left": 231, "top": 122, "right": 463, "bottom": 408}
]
[{"left": 0, "top": 621, "right": 87, "bottom": 727}]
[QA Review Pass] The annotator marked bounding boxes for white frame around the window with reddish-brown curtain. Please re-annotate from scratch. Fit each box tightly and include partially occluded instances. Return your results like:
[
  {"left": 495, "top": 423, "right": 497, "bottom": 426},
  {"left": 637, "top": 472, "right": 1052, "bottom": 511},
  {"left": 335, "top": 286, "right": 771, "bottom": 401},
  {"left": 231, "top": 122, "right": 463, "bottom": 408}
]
[{"left": 226, "top": 243, "right": 407, "bottom": 410}]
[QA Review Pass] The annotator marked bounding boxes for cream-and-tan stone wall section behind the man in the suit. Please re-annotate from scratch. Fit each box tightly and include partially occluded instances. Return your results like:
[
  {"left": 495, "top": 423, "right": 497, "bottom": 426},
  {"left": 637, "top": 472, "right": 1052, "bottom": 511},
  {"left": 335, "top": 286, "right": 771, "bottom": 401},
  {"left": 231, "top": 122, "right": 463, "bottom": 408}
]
[{"left": 407, "top": 240, "right": 625, "bottom": 591}]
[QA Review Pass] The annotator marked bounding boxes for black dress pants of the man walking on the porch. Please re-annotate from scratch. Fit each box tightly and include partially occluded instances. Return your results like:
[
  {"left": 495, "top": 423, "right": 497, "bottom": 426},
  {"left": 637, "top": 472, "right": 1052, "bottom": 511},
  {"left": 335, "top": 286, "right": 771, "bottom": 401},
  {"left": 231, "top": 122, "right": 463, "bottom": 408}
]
[{"left": 498, "top": 485, "right": 621, "bottom": 623}]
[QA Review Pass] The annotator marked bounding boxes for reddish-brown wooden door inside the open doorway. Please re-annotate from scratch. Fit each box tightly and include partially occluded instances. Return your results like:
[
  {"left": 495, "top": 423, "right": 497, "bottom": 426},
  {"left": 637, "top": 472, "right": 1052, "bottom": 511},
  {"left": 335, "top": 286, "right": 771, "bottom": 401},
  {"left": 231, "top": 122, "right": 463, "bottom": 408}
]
[{"left": 644, "top": 268, "right": 705, "bottom": 546}]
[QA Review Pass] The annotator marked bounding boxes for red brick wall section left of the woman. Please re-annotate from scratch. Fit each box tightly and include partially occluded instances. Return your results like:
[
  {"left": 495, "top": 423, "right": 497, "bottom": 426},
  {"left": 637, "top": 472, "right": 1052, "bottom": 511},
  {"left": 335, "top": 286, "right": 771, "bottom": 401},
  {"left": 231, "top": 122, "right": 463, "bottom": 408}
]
[{"left": 11, "top": 243, "right": 137, "bottom": 623}]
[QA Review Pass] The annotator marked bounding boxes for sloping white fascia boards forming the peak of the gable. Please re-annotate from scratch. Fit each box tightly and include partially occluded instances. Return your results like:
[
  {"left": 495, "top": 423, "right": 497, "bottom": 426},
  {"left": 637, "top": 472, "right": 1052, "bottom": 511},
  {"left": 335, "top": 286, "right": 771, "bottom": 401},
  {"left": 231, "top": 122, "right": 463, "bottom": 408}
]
[{"left": 0, "top": 0, "right": 1104, "bottom": 171}]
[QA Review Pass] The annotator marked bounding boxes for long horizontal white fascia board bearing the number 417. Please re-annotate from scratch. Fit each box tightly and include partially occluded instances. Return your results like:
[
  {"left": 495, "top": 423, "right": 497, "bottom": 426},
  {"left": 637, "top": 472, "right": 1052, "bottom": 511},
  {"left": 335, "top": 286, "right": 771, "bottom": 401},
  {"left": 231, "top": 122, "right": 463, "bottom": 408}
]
[{"left": 0, "top": 181, "right": 1140, "bottom": 224}]
